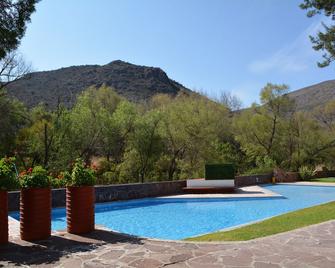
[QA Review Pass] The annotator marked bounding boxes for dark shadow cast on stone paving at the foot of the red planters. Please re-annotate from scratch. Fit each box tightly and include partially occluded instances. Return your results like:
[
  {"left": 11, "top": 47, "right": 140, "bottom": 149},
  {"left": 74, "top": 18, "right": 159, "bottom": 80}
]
[{"left": 0, "top": 230, "right": 143, "bottom": 267}]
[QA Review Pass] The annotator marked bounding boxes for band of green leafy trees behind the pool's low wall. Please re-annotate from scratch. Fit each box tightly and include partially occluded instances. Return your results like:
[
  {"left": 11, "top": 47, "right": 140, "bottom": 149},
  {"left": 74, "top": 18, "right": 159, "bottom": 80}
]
[{"left": 0, "top": 84, "right": 335, "bottom": 183}]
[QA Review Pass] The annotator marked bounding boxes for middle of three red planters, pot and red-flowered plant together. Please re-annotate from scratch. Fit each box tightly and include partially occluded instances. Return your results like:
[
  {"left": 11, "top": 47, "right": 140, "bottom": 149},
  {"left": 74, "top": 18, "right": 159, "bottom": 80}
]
[{"left": 20, "top": 166, "right": 51, "bottom": 241}]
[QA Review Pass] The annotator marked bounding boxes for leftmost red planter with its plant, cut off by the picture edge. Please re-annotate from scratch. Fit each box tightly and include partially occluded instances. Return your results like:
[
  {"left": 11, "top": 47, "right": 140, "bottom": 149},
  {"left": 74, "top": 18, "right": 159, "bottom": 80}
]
[{"left": 0, "top": 157, "right": 18, "bottom": 244}]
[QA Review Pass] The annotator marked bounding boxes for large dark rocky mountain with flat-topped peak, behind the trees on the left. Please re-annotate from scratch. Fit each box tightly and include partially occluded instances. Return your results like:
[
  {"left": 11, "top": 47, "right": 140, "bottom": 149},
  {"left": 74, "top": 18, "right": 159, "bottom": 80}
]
[{"left": 7, "top": 60, "right": 191, "bottom": 109}]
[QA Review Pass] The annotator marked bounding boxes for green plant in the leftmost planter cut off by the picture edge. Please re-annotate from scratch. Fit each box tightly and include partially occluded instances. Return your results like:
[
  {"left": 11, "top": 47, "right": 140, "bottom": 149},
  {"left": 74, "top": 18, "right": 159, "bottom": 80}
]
[{"left": 0, "top": 157, "right": 19, "bottom": 191}]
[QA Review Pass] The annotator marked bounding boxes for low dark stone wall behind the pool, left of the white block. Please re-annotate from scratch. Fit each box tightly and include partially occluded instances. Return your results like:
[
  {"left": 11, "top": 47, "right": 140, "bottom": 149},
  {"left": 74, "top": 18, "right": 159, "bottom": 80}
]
[{"left": 8, "top": 181, "right": 186, "bottom": 211}]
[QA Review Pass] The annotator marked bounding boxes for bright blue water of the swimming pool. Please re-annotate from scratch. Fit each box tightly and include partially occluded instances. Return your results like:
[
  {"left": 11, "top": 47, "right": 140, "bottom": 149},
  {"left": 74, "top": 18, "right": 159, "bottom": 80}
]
[{"left": 11, "top": 185, "right": 335, "bottom": 240}]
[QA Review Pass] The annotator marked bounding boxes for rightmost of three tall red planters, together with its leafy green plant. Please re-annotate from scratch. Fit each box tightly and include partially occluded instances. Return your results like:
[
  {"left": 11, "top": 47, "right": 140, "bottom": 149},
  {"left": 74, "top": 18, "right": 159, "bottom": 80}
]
[{"left": 64, "top": 159, "right": 95, "bottom": 234}]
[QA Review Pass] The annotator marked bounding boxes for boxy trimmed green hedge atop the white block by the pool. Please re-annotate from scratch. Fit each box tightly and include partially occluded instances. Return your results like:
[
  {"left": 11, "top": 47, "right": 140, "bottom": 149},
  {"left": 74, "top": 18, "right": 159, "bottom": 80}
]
[{"left": 205, "top": 164, "right": 235, "bottom": 180}]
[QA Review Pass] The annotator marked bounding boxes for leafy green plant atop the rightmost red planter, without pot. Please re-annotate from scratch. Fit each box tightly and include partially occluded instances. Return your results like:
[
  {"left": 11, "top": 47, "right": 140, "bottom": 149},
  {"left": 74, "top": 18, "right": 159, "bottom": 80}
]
[{"left": 67, "top": 159, "right": 96, "bottom": 186}]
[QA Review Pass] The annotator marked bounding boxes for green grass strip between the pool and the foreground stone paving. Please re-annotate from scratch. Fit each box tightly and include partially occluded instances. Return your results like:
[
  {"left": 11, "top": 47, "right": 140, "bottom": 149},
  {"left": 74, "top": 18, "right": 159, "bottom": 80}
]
[{"left": 185, "top": 202, "right": 335, "bottom": 241}]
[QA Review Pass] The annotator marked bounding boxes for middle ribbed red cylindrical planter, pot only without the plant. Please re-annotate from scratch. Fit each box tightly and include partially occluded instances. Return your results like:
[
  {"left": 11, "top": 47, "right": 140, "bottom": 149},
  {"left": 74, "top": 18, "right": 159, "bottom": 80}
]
[{"left": 20, "top": 188, "right": 51, "bottom": 241}]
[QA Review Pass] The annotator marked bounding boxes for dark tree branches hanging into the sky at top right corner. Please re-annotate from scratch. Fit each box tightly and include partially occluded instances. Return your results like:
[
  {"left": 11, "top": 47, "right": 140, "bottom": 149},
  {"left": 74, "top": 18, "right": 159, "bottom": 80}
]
[{"left": 300, "top": 0, "right": 335, "bottom": 67}]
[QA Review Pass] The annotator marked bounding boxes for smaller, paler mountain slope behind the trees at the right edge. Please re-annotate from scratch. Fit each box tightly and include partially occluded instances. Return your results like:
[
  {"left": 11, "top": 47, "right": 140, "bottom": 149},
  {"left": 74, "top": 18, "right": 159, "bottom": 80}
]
[{"left": 287, "top": 80, "right": 335, "bottom": 111}]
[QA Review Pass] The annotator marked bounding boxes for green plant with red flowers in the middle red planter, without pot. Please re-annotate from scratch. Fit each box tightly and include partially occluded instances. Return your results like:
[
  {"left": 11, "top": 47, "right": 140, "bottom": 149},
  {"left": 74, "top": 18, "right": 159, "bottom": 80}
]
[{"left": 20, "top": 166, "right": 51, "bottom": 189}]
